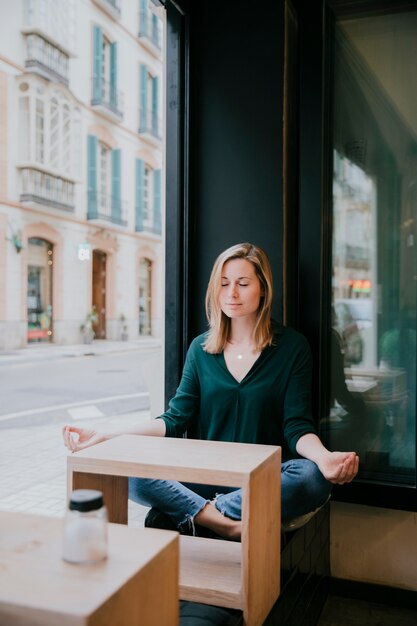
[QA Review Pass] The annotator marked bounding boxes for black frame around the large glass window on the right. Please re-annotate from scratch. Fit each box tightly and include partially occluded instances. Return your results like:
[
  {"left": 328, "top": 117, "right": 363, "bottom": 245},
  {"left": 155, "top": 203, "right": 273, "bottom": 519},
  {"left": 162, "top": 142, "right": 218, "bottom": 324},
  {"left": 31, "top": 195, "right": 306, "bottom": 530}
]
[{"left": 298, "top": 0, "right": 417, "bottom": 512}]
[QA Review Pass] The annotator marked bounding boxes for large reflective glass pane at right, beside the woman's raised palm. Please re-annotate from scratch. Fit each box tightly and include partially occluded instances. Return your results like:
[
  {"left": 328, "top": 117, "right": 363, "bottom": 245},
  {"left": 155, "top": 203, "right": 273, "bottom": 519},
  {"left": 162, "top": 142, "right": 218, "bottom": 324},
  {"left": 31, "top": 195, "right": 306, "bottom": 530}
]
[{"left": 322, "top": 12, "right": 417, "bottom": 486}]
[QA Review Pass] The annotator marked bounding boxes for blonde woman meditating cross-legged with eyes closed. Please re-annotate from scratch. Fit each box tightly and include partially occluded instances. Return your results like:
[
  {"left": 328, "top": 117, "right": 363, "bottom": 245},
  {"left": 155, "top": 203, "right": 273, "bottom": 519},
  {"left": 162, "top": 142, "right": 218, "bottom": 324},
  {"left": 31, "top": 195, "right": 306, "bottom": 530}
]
[{"left": 63, "top": 243, "right": 359, "bottom": 540}]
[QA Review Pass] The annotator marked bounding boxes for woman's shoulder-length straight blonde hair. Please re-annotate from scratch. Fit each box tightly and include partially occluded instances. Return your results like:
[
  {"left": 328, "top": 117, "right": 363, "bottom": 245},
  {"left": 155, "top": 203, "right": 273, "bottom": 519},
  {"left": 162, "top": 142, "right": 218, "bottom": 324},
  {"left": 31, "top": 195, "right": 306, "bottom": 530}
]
[{"left": 203, "top": 243, "right": 273, "bottom": 354}]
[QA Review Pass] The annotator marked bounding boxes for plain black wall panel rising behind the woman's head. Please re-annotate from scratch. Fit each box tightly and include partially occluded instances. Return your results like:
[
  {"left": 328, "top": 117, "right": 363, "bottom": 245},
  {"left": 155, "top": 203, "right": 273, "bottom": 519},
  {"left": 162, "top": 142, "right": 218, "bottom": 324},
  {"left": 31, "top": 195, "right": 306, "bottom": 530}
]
[{"left": 185, "top": 0, "right": 284, "bottom": 343}]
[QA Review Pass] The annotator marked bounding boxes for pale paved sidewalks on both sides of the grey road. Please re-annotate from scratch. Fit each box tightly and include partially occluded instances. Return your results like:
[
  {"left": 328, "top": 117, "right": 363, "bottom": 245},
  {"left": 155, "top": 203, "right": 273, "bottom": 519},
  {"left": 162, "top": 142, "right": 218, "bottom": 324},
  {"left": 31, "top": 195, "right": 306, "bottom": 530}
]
[{"left": 0, "top": 339, "right": 161, "bottom": 525}]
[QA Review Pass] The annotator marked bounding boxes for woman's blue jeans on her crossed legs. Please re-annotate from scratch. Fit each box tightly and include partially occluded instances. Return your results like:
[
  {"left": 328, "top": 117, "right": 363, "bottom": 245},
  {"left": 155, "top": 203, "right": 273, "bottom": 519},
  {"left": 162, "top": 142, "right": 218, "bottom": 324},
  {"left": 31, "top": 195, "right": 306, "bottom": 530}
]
[{"left": 129, "top": 459, "right": 332, "bottom": 528}]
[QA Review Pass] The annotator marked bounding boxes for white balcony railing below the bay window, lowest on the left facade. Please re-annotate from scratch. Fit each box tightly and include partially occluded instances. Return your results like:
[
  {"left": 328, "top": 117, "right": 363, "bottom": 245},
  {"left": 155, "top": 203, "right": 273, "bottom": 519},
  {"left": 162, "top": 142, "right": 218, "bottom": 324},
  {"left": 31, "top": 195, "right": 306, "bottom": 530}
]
[{"left": 20, "top": 168, "right": 75, "bottom": 211}]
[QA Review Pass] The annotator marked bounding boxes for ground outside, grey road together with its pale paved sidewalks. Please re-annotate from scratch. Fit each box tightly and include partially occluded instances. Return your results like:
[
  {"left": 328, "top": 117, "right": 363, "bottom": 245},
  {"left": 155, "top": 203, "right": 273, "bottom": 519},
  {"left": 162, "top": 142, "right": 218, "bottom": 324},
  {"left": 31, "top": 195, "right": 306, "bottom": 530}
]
[{"left": 0, "top": 346, "right": 162, "bottom": 523}]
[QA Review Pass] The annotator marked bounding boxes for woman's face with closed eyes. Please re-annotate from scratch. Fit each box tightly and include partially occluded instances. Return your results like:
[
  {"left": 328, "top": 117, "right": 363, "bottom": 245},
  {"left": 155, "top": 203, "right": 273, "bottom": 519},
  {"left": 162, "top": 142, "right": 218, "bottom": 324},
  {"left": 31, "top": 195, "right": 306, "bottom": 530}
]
[{"left": 219, "top": 259, "right": 262, "bottom": 319}]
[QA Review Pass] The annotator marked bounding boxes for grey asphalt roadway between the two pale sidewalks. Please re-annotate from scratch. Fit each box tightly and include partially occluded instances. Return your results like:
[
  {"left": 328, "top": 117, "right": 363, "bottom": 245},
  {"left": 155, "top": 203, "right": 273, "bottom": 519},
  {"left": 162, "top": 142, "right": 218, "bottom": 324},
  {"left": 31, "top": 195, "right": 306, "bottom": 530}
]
[{"left": 0, "top": 351, "right": 153, "bottom": 429}]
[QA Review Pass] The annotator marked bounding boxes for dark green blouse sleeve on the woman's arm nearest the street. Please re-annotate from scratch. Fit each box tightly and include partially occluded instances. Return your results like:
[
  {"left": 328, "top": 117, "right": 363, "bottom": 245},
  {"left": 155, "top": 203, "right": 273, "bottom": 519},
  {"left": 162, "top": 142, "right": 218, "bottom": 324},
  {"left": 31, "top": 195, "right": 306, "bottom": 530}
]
[{"left": 158, "top": 340, "right": 200, "bottom": 437}]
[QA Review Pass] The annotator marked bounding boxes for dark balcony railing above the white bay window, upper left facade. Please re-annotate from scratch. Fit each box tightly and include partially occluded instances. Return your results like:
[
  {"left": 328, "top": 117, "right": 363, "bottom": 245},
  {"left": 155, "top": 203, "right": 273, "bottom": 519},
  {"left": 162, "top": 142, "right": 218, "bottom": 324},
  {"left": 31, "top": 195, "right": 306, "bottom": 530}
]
[{"left": 25, "top": 34, "right": 69, "bottom": 86}]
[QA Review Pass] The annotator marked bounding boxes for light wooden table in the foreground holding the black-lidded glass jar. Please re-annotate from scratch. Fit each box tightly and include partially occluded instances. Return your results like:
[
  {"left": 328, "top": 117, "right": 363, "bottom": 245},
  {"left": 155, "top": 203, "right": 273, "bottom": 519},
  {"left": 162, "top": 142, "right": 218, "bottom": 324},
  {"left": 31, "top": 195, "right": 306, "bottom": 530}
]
[{"left": 0, "top": 513, "right": 179, "bottom": 626}]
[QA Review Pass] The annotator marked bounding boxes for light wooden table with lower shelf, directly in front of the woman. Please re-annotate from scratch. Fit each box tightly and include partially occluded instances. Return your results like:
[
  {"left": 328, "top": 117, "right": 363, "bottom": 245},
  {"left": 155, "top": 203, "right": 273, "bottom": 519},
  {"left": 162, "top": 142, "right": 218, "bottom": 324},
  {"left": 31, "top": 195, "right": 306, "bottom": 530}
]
[{"left": 68, "top": 435, "right": 281, "bottom": 625}]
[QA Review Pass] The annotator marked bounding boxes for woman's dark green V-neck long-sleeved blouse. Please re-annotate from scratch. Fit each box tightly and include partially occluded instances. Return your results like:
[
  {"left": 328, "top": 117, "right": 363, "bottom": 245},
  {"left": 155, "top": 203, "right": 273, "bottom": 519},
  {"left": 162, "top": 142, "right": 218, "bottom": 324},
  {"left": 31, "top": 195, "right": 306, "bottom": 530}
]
[{"left": 160, "top": 327, "right": 317, "bottom": 459}]
